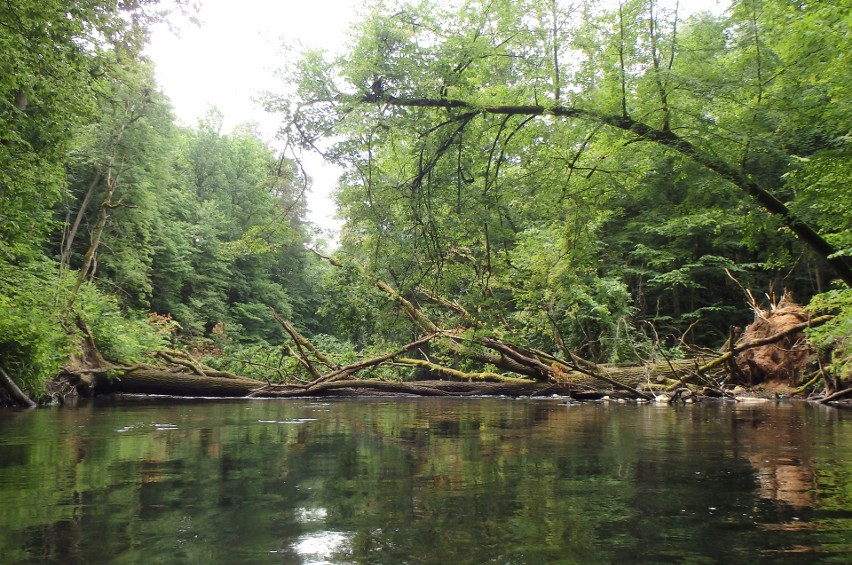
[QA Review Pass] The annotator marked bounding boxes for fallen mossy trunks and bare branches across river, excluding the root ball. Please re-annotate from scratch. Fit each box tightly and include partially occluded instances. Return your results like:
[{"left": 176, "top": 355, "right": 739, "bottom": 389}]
[{"left": 69, "top": 281, "right": 716, "bottom": 400}]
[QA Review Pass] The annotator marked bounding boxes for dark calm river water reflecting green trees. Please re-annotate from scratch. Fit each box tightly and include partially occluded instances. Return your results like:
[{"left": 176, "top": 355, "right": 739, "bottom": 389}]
[{"left": 0, "top": 398, "right": 852, "bottom": 565}]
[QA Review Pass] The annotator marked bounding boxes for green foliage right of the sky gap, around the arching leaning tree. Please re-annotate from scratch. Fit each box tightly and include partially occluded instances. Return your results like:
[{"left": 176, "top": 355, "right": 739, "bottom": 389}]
[{"left": 268, "top": 0, "right": 852, "bottom": 368}]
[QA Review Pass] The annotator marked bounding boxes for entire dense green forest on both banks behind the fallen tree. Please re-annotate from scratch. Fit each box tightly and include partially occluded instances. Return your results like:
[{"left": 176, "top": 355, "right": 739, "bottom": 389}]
[{"left": 0, "top": 0, "right": 852, "bottom": 402}]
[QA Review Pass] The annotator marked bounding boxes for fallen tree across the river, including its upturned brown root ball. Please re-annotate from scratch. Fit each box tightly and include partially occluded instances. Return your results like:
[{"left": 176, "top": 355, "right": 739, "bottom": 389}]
[{"left": 50, "top": 281, "right": 845, "bottom": 402}]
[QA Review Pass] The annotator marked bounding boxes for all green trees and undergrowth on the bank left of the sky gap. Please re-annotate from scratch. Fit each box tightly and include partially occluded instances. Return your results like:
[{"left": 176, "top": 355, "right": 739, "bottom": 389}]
[{"left": 0, "top": 0, "right": 326, "bottom": 393}]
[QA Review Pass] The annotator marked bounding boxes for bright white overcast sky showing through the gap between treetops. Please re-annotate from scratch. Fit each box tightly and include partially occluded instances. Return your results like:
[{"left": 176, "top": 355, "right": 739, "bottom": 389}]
[{"left": 147, "top": 0, "right": 728, "bottom": 241}]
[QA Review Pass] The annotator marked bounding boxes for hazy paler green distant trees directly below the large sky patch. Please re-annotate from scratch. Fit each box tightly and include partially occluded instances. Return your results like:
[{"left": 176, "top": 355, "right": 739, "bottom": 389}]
[{"left": 143, "top": 110, "right": 315, "bottom": 344}]
